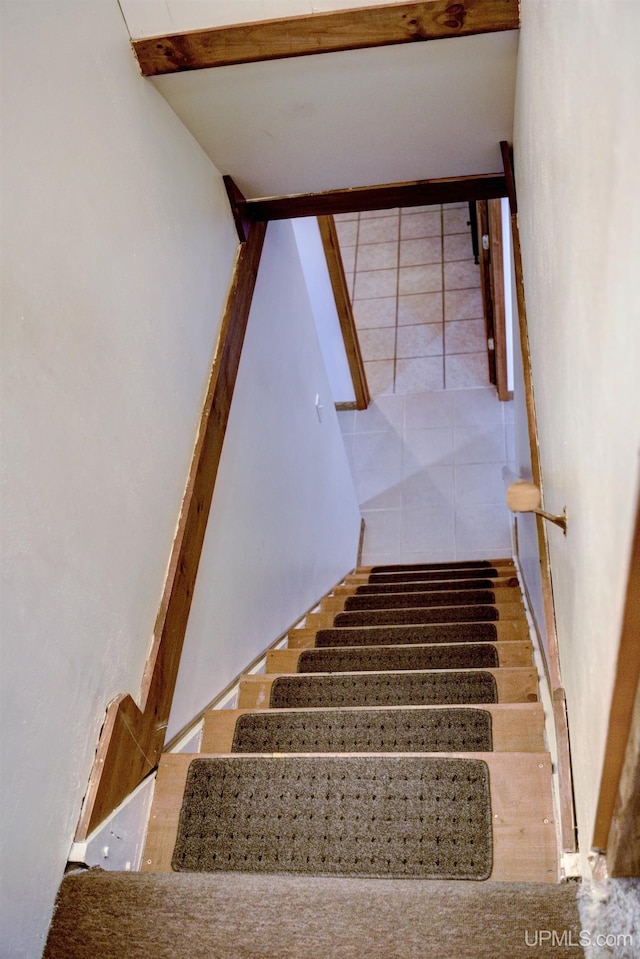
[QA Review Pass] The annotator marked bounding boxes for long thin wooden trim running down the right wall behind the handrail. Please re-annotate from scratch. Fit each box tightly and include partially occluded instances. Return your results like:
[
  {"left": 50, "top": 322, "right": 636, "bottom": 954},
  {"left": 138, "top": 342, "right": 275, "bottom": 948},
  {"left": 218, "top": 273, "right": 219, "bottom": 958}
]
[{"left": 511, "top": 214, "right": 577, "bottom": 852}]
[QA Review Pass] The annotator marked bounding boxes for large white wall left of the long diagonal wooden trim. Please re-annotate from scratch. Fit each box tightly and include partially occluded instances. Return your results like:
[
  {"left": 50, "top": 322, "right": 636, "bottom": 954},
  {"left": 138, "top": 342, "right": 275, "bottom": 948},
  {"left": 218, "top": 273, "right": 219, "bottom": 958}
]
[{"left": 0, "top": 0, "right": 232, "bottom": 959}]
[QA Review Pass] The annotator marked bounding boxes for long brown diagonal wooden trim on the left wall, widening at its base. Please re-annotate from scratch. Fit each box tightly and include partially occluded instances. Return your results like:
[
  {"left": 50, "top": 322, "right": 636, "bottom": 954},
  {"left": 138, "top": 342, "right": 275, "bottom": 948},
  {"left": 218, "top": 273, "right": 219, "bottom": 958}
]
[{"left": 76, "top": 224, "right": 267, "bottom": 842}]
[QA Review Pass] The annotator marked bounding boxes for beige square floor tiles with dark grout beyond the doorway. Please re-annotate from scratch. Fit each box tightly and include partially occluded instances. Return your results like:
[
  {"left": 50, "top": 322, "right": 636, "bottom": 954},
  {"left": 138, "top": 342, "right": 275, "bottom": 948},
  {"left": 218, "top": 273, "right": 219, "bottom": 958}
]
[{"left": 336, "top": 203, "right": 489, "bottom": 397}]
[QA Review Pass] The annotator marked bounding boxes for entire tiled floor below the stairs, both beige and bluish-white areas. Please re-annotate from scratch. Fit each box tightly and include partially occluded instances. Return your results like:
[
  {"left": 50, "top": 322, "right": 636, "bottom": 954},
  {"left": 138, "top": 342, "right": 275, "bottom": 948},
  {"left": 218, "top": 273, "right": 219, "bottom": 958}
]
[{"left": 336, "top": 203, "right": 513, "bottom": 564}]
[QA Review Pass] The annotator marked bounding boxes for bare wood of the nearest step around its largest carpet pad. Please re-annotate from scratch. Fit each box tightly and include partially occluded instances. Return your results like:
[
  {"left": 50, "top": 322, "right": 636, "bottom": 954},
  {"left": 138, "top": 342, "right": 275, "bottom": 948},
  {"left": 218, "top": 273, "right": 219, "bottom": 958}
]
[{"left": 141, "top": 752, "right": 558, "bottom": 883}]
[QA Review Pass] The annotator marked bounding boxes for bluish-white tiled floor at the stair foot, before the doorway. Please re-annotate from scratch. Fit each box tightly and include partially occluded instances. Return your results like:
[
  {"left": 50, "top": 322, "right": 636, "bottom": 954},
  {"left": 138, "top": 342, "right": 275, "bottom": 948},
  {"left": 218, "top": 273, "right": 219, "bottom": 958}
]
[{"left": 338, "top": 392, "right": 512, "bottom": 564}]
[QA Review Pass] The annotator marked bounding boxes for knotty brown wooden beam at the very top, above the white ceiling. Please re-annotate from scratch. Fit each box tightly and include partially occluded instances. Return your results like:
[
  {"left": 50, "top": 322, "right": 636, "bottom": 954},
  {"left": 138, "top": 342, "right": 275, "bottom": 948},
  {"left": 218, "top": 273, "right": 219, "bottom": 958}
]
[{"left": 132, "top": 0, "right": 520, "bottom": 77}]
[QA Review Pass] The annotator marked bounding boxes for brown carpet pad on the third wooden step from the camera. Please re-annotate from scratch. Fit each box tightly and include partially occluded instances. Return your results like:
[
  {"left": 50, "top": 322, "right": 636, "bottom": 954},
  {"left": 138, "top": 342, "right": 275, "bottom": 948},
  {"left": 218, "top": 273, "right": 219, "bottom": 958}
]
[{"left": 269, "top": 670, "right": 498, "bottom": 709}]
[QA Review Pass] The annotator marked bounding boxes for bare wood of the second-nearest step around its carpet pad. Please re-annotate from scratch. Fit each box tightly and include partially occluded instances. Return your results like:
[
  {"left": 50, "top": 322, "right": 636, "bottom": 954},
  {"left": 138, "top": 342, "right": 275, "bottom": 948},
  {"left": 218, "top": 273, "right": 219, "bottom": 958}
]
[{"left": 200, "top": 703, "right": 545, "bottom": 755}]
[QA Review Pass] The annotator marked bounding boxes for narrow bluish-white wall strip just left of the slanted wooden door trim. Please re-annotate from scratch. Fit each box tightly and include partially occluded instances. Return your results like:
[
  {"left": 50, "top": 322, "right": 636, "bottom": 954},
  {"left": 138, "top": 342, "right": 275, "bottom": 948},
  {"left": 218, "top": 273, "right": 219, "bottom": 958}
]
[{"left": 291, "top": 216, "right": 356, "bottom": 403}]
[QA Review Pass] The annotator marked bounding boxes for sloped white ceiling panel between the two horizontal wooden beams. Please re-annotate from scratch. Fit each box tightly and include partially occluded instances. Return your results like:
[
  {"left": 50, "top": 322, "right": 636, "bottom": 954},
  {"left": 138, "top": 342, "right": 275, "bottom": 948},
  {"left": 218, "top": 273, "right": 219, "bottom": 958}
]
[{"left": 139, "top": 22, "right": 518, "bottom": 198}]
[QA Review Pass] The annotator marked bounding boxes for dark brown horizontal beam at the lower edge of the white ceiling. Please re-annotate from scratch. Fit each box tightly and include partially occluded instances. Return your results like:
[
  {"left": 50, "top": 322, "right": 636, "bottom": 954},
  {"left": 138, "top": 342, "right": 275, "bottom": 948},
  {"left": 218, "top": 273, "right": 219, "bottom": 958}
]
[{"left": 247, "top": 173, "right": 507, "bottom": 221}]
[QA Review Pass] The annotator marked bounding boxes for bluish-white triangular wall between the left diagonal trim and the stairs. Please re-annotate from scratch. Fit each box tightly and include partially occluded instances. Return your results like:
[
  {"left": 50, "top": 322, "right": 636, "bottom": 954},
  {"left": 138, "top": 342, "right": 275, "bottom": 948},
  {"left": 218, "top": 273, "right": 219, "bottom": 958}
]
[{"left": 168, "top": 221, "right": 360, "bottom": 738}]
